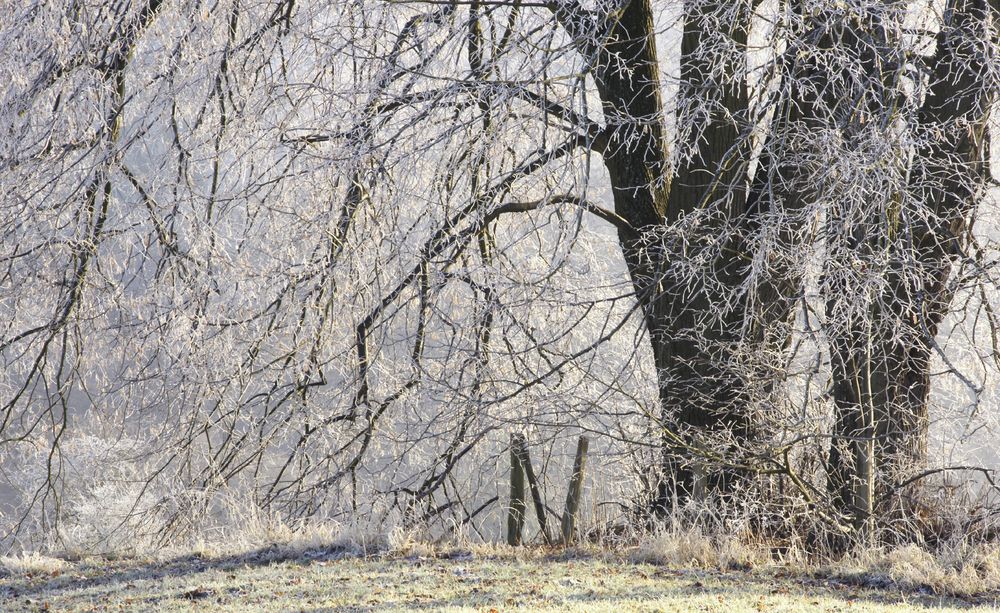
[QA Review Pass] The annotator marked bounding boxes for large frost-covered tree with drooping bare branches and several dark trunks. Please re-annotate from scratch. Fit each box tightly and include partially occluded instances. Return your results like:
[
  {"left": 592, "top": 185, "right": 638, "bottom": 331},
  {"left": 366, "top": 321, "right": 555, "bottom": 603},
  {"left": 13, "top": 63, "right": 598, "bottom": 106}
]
[{"left": 0, "top": 0, "right": 1000, "bottom": 544}]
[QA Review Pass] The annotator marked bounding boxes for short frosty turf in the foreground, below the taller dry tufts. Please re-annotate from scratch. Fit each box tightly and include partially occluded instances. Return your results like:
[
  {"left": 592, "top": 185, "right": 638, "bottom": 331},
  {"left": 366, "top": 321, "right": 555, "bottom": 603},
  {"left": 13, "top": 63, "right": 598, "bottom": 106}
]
[{"left": 0, "top": 549, "right": 1000, "bottom": 613}]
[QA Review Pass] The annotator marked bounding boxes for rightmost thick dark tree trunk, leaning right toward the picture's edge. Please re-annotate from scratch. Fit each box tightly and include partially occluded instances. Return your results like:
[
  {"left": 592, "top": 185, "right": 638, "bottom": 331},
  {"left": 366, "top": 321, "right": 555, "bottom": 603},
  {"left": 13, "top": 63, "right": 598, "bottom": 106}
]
[{"left": 877, "top": 0, "right": 1000, "bottom": 508}]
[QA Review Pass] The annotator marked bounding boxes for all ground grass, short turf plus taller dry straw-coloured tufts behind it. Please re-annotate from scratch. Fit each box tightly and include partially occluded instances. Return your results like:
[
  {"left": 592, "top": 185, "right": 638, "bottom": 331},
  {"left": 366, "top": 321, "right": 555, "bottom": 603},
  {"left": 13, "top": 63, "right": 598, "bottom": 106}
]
[{"left": 0, "top": 521, "right": 1000, "bottom": 613}]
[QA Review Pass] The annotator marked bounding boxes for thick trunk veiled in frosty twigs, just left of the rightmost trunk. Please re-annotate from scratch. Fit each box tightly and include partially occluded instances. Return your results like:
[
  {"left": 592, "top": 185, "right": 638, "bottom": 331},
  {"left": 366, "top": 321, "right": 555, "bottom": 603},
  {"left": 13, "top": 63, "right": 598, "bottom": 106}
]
[{"left": 824, "top": 2, "right": 905, "bottom": 547}]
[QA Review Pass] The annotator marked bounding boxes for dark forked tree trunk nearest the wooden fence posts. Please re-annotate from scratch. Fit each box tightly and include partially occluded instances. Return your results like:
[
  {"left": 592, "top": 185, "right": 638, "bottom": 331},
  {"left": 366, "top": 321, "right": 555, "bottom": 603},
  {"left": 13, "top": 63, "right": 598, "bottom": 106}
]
[{"left": 597, "top": 0, "right": 754, "bottom": 510}]
